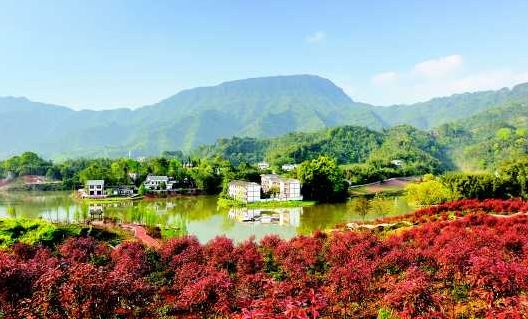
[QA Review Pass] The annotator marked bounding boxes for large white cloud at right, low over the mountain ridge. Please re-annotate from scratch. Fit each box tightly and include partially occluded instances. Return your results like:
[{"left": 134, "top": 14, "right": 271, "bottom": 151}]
[{"left": 366, "top": 54, "right": 528, "bottom": 105}]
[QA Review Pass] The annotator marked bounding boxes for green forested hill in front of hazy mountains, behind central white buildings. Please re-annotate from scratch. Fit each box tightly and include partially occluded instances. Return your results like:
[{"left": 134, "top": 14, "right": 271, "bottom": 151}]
[{"left": 193, "top": 125, "right": 452, "bottom": 179}]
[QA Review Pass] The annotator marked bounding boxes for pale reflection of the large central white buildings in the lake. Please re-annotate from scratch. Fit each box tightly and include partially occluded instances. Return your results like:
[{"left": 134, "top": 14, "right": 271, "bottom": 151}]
[{"left": 229, "top": 207, "right": 303, "bottom": 227}]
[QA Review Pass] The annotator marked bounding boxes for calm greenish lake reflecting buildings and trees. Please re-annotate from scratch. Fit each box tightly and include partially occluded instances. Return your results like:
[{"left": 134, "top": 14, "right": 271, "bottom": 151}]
[{"left": 0, "top": 192, "right": 414, "bottom": 242}]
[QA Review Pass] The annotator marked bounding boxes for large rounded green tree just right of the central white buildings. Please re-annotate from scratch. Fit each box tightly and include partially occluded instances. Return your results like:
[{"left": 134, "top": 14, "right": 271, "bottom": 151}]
[{"left": 297, "top": 156, "right": 348, "bottom": 202}]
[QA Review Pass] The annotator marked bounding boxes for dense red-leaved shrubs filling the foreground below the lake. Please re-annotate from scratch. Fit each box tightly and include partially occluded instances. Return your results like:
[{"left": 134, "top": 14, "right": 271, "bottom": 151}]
[{"left": 0, "top": 200, "right": 528, "bottom": 318}]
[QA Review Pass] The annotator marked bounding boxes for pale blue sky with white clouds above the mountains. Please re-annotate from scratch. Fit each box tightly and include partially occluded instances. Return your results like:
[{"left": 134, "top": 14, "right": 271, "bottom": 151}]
[{"left": 0, "top": 0, "right": 528, "bottom": 109}]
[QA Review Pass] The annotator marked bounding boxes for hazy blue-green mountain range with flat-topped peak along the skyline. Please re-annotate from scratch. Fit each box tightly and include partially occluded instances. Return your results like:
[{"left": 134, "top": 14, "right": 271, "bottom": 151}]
[{"left": 0, "top": 75, "right": 528, "bottom": 158}]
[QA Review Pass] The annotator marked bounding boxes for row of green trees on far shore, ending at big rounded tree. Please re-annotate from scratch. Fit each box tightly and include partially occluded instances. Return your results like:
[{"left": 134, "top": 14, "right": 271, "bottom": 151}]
[{"left": 0, "top": 152, "right": 347, "bottom": 202}]
